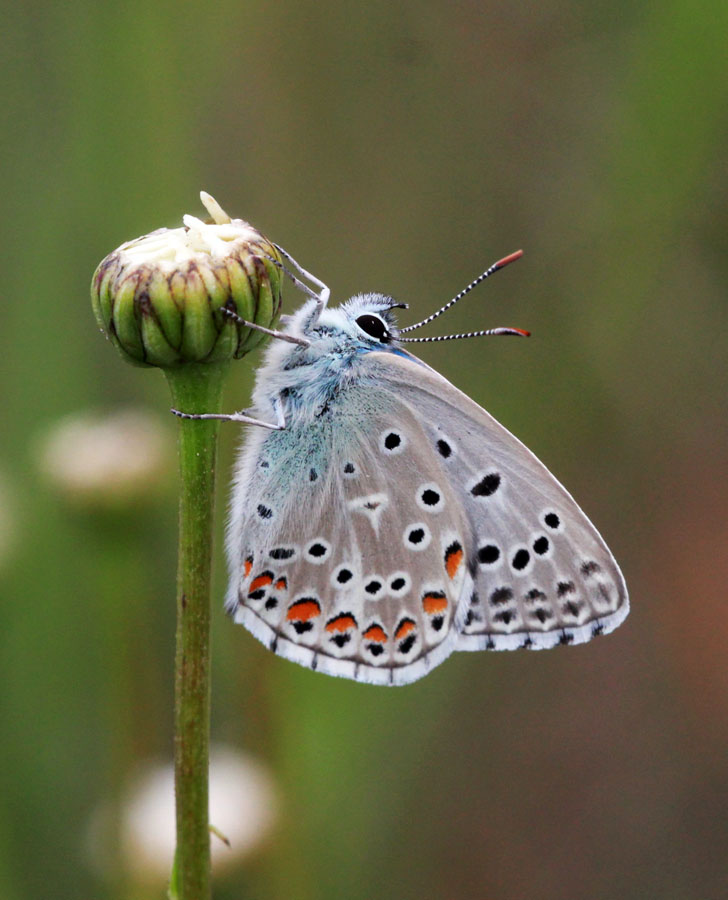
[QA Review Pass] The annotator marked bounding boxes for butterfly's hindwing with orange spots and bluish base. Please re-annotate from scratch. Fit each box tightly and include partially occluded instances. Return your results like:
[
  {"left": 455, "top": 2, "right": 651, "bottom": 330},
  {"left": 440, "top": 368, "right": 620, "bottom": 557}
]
[{"left": 227, "top": 378, "right": 472, "bottom": 684}]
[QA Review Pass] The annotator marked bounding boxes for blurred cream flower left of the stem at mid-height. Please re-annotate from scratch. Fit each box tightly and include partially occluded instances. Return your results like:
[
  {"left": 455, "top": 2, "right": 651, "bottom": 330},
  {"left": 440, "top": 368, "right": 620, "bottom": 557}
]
[{"left": 40, "top": 409, "right": 175, "bottom": 506}]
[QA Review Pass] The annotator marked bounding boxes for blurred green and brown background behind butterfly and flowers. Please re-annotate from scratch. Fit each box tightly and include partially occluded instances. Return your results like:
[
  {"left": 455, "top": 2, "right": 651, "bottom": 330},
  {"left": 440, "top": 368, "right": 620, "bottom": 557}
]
[{"left": 0, "top": 0, "right": 728, "bottom": 900}]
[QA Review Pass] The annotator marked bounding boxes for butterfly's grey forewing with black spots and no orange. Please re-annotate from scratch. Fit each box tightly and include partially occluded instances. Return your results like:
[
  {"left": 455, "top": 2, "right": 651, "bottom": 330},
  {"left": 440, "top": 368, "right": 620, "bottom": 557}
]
[{"left": 371, "top": 353, "right": 629, "bottom": 650}]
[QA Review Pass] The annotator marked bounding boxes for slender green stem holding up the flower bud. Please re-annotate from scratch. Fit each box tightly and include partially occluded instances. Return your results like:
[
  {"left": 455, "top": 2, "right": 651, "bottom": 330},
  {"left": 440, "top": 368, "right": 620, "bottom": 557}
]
[{"left": 165, "top": 362, "right": 229, "bottom": 900}]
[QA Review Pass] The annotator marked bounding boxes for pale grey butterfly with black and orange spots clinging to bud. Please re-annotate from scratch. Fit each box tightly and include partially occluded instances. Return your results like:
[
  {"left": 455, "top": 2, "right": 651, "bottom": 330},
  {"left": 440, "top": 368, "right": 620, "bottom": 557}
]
[{"left": 175, "top": 248, "right": 629, "bottom": 685}]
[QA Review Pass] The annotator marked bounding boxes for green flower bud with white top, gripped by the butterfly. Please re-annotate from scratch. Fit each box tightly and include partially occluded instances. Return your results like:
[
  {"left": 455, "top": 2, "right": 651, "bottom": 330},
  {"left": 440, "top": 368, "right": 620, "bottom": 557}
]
[{"left": 91, "top": 191, "right": 282, "bottom": 368}]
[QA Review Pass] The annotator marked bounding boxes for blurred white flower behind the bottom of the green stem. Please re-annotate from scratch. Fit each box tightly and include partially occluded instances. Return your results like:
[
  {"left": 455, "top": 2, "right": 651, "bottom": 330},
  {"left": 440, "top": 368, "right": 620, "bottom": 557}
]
[{"left": 90, "top": 746, "right": 278, "bottom": 884}]
